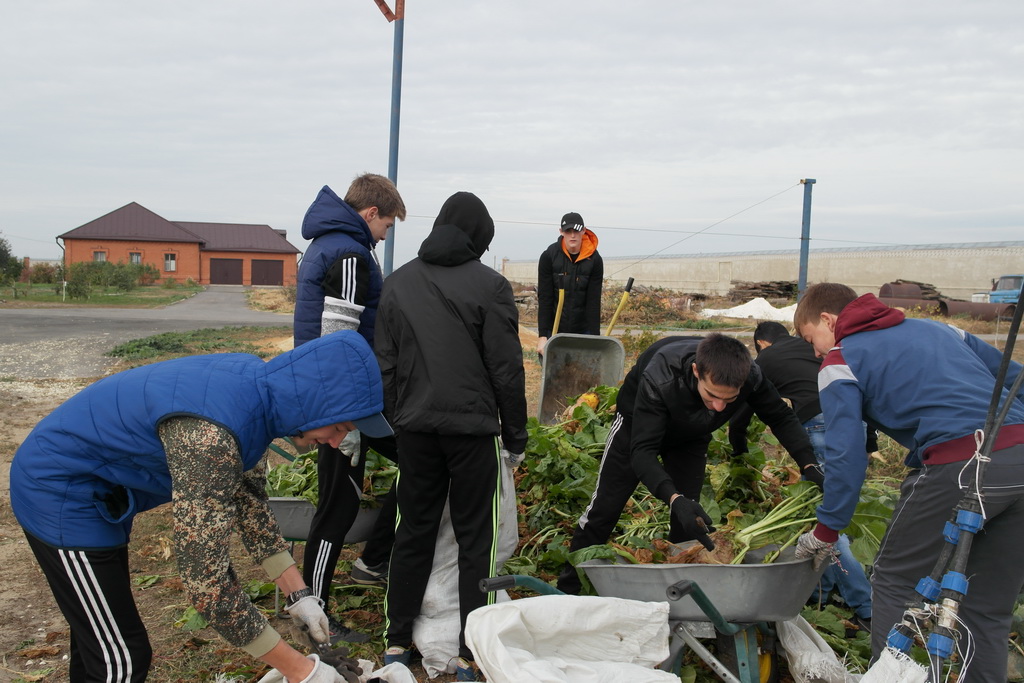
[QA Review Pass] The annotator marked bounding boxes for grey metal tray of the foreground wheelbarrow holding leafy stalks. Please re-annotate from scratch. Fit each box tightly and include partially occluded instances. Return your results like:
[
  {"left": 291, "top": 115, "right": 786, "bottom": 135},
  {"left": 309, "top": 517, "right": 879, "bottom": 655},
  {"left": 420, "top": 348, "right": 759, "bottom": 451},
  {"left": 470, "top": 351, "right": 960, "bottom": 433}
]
[{"left": 579, "top": 559, "right": 824, "bottom": 624}]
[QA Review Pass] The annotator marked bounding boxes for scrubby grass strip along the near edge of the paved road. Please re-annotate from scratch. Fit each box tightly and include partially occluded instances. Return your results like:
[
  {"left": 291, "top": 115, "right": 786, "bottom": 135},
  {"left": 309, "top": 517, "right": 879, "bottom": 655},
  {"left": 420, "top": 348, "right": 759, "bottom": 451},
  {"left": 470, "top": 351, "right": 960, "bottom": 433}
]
[{"left": 106, "top": 326, "right": 292, "bottom": 366}]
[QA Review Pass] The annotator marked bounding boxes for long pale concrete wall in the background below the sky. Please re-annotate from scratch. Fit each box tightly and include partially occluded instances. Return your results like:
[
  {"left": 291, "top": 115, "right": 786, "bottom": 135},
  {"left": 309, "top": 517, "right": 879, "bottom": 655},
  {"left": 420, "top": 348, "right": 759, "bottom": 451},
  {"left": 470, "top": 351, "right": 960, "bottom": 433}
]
[{"left": 502, "top": 242, "right": 1024, "bottom": 300}]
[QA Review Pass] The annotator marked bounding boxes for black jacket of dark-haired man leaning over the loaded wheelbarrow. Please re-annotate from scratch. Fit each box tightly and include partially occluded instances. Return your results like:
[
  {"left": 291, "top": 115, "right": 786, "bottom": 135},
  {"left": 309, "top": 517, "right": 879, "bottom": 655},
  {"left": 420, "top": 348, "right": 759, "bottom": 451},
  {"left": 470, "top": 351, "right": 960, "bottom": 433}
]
[{"left": 616, "top": 337, "right": 816, "bottom": 503}]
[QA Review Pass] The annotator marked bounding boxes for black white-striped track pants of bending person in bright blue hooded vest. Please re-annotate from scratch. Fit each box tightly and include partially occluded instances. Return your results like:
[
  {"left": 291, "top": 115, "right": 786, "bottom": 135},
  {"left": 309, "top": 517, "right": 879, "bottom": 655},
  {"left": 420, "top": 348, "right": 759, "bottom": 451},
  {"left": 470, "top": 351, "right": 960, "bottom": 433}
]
[{"left": 25, "top": 533, "right": 153, "bottom": 683}]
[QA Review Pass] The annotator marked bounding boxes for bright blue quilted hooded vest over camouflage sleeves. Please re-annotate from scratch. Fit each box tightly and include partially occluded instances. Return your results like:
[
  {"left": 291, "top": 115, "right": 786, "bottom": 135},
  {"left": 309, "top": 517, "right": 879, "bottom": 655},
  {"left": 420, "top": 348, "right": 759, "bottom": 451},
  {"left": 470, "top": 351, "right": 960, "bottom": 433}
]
[{"left": 10, "top": 331, "right": 384, "bottom": 549}]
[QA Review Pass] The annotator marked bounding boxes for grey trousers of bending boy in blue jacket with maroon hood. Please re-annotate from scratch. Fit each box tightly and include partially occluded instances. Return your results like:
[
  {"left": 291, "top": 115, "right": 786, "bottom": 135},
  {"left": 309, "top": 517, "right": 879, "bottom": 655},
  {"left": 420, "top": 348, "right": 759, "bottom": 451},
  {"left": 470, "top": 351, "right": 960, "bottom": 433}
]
[{"left": 871, "top": 445, "right": 1024, "bottom": 683}]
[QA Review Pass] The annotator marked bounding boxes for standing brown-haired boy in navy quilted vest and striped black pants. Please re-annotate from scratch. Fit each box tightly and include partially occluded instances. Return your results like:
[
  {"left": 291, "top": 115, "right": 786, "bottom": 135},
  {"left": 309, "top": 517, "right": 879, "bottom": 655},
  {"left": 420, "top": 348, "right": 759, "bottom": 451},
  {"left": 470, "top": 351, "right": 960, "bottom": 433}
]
[{"left": 294, "top": 173, "right": 406, "bottom": 642}]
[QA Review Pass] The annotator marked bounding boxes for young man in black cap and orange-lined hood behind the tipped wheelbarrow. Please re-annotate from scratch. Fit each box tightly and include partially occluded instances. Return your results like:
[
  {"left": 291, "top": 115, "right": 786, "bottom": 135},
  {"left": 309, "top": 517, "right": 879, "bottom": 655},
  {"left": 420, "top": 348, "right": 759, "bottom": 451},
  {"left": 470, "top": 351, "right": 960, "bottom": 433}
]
[{"left": 537, "top": 212, "right": 604, "bottom": 354}]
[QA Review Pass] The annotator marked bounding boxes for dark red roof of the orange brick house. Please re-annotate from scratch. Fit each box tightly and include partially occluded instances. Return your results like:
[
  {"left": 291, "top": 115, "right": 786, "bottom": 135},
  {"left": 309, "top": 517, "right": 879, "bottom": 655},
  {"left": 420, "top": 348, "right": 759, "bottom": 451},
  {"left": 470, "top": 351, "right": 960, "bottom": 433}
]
[{"left": 58, "top": 202, "right": 299, "bottom": 254}]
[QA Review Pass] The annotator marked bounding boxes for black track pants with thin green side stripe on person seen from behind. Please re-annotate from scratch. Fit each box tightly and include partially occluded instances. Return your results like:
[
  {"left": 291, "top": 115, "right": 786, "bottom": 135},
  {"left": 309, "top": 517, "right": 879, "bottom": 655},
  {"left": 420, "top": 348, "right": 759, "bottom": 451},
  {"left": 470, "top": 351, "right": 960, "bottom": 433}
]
[{"left": 385, "top": 432, "right": 501, "bottom": 658}]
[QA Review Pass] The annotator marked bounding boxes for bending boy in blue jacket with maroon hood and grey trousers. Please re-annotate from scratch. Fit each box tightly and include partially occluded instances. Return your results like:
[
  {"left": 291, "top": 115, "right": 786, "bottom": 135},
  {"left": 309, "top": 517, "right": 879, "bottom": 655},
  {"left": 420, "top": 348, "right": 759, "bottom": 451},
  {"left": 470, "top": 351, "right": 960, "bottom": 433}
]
[{"left": 794, "top": 283, "right": 1024, "bottom": 681}]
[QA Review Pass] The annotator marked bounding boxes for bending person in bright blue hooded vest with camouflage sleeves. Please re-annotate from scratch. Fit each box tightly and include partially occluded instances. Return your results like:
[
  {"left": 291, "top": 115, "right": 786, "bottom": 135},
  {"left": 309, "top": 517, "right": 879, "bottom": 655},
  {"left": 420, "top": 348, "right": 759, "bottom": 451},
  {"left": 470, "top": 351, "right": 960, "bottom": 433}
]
[{"left": 10, "top": 331, "right": 391, "bottom": 683}]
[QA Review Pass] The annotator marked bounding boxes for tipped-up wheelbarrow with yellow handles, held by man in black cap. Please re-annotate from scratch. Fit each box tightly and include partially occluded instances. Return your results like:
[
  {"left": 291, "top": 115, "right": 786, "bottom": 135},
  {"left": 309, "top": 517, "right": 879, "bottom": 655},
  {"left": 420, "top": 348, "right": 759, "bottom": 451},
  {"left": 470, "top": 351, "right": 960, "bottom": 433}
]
[{"left": 537, "top": 278, "right": 633, "bottom": 424}]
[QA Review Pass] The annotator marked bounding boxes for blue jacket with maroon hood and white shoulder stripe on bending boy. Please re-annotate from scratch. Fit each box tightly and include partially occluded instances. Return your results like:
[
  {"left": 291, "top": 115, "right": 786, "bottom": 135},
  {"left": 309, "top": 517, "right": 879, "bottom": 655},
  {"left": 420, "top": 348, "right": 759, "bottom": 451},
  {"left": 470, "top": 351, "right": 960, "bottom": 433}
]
[{"left": 816, "top": 294, "right": 1024, "bottom": 533}]
